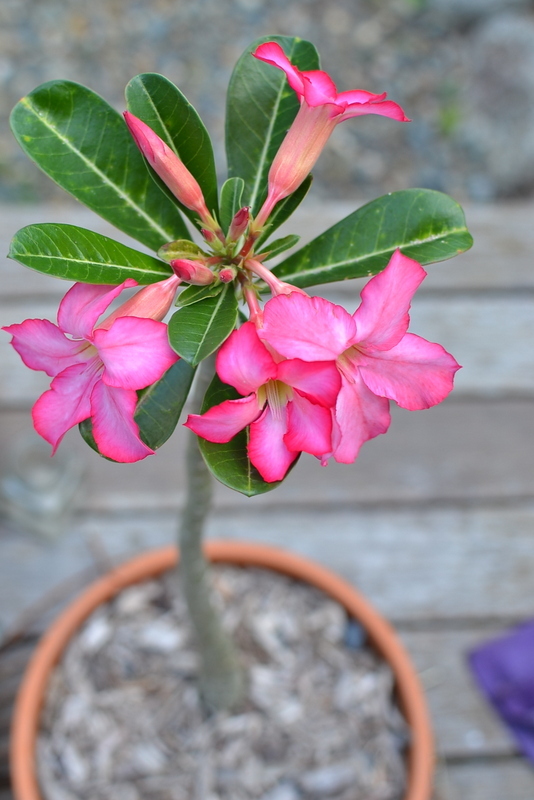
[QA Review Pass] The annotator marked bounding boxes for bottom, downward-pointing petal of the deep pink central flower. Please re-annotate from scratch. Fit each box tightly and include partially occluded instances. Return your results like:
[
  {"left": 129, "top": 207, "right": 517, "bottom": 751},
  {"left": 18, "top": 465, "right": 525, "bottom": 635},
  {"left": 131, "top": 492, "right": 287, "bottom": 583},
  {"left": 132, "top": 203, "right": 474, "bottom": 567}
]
[{"left": 248, "top": 406, "right": 298, "bottom": 483}]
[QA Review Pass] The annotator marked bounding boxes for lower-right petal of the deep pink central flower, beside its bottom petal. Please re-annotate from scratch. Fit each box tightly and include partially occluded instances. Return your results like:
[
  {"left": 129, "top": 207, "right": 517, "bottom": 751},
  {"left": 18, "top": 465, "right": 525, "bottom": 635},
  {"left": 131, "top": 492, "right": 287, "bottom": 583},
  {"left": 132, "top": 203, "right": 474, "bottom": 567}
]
[{"left": 284, "top": 392, "right": 332, "bottom": 458}]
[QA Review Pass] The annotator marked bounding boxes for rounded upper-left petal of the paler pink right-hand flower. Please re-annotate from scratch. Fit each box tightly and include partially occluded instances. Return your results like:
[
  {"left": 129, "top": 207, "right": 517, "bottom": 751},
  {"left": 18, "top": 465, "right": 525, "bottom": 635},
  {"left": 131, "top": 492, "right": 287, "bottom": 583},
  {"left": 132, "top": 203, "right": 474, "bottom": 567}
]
[{"left": 258, "top": 292, "right": 356, "bottom": 361}]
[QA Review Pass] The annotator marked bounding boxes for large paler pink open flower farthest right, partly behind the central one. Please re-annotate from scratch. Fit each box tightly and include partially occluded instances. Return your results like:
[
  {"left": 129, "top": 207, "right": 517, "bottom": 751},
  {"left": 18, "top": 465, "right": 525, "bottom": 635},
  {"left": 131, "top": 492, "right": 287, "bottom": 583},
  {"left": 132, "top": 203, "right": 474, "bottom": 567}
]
[{"left": 258, "top": 250, "right": 459, "bottom": 464}]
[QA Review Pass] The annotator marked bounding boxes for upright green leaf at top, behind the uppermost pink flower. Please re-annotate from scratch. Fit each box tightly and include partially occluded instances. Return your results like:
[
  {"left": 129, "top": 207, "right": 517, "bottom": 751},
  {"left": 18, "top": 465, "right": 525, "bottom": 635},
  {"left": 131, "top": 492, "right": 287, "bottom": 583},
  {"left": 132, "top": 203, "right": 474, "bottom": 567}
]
[{"left": 226, "top": 36, "right": 319, "bottom": 216}]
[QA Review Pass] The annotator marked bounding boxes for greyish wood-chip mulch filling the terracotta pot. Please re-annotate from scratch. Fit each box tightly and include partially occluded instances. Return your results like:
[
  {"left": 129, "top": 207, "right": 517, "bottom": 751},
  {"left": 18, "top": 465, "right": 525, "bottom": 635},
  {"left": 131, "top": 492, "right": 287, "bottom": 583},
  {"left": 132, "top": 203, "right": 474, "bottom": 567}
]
[{"left": 37, "top": 565, "right": 407, "bottom": 800}]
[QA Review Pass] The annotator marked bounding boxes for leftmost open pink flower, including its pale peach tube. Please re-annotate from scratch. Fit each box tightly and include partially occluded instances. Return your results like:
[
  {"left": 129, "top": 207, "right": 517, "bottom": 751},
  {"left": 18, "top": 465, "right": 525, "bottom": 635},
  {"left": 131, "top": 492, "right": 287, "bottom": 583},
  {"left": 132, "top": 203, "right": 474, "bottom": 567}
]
[{"left": 3, "top": 275, "right": 180, "bottom": 462}]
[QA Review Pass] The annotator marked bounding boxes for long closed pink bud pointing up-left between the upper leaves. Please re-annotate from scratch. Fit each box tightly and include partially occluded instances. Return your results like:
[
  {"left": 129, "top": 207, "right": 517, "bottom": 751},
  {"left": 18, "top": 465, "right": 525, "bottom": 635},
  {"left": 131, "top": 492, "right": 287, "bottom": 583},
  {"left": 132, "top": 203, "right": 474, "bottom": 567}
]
[{"left": 124, "top": 111, "right": 218, "bottom": 228}]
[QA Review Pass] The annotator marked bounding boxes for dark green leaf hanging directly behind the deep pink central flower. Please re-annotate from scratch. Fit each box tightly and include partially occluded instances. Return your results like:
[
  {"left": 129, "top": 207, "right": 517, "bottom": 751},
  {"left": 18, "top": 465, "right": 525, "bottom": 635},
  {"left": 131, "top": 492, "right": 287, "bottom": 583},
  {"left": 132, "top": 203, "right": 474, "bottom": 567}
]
[{"left": 198, "top": 375, "right": 288, "bottom": 497}]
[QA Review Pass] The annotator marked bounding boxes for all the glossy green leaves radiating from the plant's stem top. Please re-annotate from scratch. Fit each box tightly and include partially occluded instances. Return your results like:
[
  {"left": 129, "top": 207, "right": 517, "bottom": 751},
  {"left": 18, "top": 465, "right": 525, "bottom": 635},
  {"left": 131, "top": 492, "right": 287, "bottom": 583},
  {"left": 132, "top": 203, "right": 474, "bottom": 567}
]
[{"left": 9, "top": 36, "right": 472, "bottom": 496}]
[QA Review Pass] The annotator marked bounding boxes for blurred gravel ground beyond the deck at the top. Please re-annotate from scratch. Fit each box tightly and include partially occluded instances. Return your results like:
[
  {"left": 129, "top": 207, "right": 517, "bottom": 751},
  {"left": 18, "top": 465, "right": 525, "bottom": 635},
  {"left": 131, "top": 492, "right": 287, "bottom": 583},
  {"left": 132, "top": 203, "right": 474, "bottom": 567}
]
[{"left": 0, "top": 0, "right": 534, "bottom": 201}]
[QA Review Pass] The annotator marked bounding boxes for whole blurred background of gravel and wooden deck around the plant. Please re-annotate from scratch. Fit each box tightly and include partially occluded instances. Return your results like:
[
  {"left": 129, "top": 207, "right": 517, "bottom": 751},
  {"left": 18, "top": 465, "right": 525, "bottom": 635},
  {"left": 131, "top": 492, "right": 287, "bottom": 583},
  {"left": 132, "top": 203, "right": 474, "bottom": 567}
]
[{"left": 0, "top": 0, "right": 534, "bottom": 800}]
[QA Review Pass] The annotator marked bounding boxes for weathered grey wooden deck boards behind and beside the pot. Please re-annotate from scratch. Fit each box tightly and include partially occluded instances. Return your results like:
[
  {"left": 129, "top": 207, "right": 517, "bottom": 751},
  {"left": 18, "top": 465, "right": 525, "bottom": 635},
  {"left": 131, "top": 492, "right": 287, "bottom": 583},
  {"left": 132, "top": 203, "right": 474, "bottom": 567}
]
[{"left": 0, "top": 201, "right": 534, "bottom": 788}]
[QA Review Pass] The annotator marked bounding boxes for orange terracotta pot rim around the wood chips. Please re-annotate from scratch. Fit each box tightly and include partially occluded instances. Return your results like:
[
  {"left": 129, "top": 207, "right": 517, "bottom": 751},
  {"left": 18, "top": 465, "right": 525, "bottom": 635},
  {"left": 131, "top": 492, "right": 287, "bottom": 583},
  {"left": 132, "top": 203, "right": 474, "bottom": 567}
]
[{"left": 10, "top": 542, "right": 434, "bottom": 800}]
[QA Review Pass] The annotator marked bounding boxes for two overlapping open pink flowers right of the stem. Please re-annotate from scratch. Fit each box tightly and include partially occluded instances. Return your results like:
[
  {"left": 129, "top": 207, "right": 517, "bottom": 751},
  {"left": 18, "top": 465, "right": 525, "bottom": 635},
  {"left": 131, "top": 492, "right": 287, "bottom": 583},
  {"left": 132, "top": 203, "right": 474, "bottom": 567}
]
[{"left": 186, "top": 251, "right": 459, "bottom": 481}]
